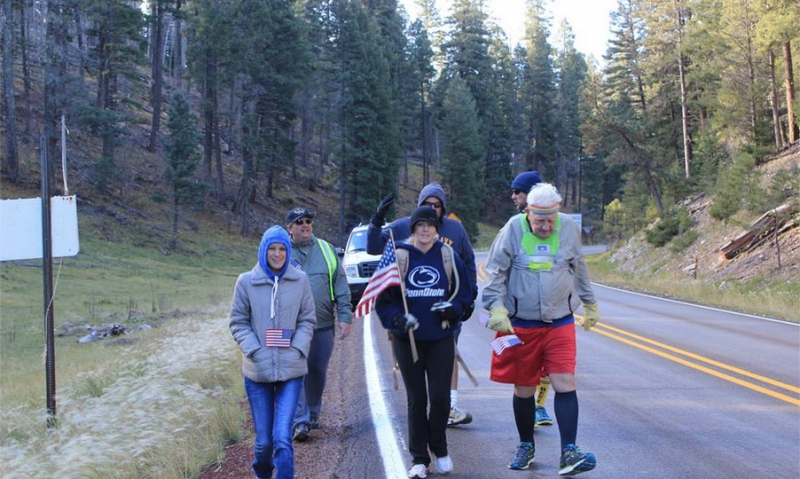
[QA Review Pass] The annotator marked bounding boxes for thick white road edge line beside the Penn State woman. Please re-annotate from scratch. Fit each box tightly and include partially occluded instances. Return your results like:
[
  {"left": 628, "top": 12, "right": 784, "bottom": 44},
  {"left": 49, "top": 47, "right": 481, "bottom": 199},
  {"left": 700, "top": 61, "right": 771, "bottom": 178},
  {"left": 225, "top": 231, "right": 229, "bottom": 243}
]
[{"left": 363, "top": 313, "right": 406, "bottom": 477}]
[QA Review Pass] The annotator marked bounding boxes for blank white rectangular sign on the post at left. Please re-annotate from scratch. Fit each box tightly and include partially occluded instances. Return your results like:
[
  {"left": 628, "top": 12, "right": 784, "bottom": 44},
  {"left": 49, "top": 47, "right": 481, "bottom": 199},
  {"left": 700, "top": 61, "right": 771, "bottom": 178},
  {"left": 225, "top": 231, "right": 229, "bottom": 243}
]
[{"left": 0, "top": 196, "right": 80, "bottom": 261}]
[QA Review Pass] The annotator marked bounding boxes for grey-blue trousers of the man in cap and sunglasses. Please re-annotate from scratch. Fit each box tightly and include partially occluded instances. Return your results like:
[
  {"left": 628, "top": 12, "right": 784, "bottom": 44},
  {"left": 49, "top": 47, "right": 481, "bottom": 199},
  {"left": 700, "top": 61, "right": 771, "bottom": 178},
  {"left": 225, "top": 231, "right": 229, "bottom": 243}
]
[{"left": 294, "top": 327, "right": 335, "bottom": 427}]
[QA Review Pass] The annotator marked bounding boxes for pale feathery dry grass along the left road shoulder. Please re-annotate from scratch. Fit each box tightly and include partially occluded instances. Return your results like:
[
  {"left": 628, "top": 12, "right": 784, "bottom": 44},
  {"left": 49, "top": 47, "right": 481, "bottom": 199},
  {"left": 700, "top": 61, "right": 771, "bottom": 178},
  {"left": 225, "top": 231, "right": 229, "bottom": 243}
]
[{"left": 0, "top": 311, "right": 242, "bottom": 478}]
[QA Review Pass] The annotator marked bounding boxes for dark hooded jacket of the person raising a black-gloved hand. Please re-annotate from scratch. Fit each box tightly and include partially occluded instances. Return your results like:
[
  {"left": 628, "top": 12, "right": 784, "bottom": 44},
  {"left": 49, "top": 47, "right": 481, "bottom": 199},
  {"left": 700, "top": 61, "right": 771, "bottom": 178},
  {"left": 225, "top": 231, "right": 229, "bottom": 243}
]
[{"left": 367, "top": 183, "right": 478, "bottom": 299}]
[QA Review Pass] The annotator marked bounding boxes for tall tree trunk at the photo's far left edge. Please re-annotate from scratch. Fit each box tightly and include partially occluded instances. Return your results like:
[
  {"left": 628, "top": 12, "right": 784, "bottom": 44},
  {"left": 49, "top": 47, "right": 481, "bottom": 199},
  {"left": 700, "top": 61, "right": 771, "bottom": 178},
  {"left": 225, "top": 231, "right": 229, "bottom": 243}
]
[{"left": 2, "top": 0, "right": 19, "bottom": 183}]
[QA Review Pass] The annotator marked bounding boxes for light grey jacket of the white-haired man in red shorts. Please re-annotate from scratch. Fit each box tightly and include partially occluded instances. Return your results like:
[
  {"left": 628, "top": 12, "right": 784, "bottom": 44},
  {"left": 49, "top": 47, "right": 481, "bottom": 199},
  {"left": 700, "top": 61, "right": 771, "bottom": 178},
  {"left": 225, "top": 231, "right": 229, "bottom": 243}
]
[{"left": 483, "top": 213, "right": 597, "bottom": 323}]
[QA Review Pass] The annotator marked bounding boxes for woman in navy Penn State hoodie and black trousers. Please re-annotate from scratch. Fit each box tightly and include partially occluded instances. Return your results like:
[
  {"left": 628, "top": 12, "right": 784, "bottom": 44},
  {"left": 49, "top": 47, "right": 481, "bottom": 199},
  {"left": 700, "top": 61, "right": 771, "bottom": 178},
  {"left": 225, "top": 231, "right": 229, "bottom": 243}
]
[{"left": 375, "top": 206, "right": 472, "bottom": 479}]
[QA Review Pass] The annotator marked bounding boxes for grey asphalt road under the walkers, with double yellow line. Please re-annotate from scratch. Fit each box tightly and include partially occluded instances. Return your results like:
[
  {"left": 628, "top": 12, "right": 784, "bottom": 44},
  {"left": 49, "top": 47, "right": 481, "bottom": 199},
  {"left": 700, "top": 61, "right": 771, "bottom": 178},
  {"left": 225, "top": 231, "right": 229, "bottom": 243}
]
[{"left": 364, "top": 254, "right": 800, "bottom": 479}]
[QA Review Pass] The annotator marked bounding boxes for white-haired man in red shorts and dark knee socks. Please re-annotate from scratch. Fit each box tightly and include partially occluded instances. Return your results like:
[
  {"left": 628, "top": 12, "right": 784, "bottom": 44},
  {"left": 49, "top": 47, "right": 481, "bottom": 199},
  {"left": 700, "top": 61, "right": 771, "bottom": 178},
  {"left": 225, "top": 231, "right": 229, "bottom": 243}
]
[{"left": 483, "top": 183, "right": 599, "bottom": 475}]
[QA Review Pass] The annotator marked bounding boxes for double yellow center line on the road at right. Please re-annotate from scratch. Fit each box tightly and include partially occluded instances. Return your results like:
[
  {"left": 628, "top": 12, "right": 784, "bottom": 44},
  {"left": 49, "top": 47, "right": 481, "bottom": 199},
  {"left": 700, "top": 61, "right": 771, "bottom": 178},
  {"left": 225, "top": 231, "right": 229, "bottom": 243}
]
[{"left": 588, "top": 324, "right": 800, "bottom": 406}]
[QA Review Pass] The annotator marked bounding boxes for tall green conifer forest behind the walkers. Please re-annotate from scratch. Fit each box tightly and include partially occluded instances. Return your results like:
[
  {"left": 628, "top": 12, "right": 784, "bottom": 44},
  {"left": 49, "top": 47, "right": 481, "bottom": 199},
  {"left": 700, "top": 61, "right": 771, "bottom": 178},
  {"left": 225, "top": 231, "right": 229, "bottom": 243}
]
[{"left": 0, "top": 0, "right": 800, "bottom": 240}]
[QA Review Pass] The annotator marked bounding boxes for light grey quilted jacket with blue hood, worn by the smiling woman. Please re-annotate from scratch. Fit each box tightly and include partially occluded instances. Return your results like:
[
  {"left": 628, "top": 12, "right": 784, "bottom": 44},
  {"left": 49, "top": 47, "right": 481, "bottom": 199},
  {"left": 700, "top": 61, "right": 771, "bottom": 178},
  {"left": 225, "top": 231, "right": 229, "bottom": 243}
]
[{"left": 228, "top": 226, "right": 317, "bottom": 383}]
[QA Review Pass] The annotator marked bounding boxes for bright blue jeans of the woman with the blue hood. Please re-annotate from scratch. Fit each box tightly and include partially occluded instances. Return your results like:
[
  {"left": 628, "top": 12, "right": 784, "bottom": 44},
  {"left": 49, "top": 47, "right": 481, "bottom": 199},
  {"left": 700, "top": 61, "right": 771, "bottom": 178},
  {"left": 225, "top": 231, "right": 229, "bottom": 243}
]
[{"left": 244, "top": 376, "right": 303, "bottom": 479}]
